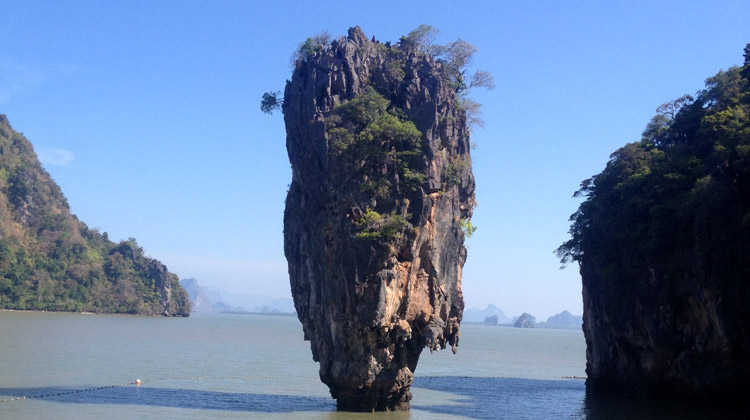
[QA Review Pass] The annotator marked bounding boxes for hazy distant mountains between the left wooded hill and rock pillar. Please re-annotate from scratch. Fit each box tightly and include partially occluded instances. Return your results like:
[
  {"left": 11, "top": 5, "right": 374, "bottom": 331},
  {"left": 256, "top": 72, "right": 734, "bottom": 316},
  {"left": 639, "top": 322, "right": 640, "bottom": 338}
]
[{"left": 180, "top": 278, "right": 296, "bottom": 315}]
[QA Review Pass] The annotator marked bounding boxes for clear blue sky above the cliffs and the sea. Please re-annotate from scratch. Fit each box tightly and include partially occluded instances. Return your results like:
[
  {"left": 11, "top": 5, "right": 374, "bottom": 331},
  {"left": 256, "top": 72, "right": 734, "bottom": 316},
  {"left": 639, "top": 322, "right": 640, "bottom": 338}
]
[{"left": 0, "top": 0, "right": 750, "bottom": 320}]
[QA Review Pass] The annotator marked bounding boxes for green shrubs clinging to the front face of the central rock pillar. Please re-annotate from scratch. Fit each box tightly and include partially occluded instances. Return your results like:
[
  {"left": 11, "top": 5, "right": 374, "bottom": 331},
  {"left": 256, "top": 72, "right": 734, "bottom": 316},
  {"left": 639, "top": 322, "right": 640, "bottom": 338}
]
[{"left": 324, "top": 87, "right": 427, "bottom": 244}]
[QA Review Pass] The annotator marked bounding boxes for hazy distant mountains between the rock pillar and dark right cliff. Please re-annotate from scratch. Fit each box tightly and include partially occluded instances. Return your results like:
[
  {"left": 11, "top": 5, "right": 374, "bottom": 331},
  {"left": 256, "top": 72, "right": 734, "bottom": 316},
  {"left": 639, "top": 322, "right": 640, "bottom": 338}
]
[{"left": 463, "top": 304, "right": 583, "bottom": 330}]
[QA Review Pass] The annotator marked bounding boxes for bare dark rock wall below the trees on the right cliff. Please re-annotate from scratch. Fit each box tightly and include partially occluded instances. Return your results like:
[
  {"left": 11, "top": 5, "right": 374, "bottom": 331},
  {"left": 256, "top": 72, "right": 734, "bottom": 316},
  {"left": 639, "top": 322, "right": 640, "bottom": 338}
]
[{"left": 582, "top": 260, "right": 750, "bottom": 399}]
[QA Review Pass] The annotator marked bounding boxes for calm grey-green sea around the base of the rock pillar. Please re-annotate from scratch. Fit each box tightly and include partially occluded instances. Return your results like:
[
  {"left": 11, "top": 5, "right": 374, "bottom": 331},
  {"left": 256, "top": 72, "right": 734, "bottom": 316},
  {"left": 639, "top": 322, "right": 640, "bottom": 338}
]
[{"left": 0, "top": 312, "right": 742, "bottom": 420}]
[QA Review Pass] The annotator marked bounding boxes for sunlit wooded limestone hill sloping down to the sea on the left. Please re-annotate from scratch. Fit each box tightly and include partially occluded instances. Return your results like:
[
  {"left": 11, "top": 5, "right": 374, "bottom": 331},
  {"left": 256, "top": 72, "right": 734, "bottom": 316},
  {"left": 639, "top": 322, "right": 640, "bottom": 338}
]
[{"left": 0, "top": 115, "right": 190, "bottom": 316}]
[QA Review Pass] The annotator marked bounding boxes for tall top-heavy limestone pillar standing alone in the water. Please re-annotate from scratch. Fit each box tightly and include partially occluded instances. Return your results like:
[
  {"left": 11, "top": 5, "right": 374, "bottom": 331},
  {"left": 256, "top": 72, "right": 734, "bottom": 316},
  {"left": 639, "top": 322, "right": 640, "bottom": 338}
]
[{"left": 283, "top": 27, "right": 474, "bottom": 411}]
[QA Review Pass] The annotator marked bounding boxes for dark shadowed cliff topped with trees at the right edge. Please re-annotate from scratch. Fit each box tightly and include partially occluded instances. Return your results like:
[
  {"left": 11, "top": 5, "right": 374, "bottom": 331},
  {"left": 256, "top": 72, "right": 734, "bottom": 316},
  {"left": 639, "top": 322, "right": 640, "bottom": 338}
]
[{"left": 558, "top": 44, "right": 750, "bottom": 402}]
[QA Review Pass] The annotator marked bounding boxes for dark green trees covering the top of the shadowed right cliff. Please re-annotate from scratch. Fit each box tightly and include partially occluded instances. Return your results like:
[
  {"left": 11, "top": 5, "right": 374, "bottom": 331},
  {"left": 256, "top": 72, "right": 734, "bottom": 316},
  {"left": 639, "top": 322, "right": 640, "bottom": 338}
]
[{"left": 556, "top": 49, "right": 750, "bottom": 281}]
